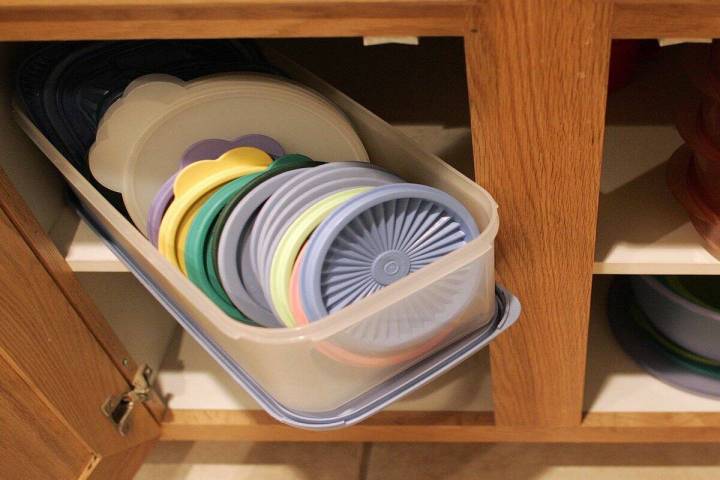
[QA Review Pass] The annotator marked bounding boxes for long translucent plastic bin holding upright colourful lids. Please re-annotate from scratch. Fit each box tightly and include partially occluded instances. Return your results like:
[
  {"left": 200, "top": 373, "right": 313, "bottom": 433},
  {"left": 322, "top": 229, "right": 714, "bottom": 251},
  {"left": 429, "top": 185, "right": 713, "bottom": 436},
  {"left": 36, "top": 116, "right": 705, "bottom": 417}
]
[{"left": 16, "top": 48, "right": 519, "bottom": 429}]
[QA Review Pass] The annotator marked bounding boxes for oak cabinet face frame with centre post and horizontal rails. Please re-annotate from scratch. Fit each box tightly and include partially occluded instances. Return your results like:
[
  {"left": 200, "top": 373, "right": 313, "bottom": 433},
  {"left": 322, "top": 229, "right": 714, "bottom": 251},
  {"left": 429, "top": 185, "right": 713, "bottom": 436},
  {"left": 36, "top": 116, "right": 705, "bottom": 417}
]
[{"left": 0, "top": 0, "right": 720, "bottom": 460}]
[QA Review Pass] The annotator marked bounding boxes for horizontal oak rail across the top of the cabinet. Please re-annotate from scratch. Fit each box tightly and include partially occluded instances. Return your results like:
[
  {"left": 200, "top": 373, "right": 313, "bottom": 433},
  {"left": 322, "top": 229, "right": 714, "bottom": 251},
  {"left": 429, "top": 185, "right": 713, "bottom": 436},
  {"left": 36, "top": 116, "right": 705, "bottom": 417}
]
[{"left": 0, "top": 0, "right": 720, "bottom": 40}]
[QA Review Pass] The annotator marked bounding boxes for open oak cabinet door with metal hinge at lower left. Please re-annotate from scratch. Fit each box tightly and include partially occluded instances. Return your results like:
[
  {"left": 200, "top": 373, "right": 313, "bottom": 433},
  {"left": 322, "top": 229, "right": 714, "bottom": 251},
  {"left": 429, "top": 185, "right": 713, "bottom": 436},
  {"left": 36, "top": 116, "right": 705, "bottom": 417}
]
[{"left": 0, "top": 171, "right": 160, "bottom": 480}]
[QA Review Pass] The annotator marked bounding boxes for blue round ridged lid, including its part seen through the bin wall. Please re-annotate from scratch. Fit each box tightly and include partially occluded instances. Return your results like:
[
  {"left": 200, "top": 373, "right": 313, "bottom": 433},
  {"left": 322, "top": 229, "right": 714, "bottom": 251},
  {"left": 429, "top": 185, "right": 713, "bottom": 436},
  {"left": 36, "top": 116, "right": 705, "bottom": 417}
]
[{"left": 300, "top": 183, "right": 479, "bottom": 353}]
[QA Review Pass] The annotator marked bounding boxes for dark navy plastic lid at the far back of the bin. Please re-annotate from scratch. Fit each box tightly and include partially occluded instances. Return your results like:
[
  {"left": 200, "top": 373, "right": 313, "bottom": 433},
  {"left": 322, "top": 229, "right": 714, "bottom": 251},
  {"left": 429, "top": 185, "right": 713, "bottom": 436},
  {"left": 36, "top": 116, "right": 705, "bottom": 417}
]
[{"left": 16, "top": 40, "right": 280, "bottom": 212}]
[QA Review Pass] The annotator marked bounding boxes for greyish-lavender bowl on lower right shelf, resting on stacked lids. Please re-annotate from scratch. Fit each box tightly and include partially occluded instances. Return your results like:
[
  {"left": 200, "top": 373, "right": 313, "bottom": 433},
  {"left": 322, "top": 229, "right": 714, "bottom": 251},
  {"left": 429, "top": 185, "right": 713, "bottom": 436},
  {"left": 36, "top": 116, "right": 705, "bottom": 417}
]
[{"left": 632, "top": 276, "right": 720, "bottom": 361}]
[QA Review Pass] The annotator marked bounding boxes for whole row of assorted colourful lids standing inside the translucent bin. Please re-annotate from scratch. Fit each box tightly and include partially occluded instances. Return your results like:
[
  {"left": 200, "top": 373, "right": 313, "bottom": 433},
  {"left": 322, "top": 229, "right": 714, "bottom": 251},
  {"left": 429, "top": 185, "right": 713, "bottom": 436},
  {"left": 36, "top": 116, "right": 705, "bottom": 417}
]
[{"left": 84, "top": 73, "right": 479, "bottom": 356}]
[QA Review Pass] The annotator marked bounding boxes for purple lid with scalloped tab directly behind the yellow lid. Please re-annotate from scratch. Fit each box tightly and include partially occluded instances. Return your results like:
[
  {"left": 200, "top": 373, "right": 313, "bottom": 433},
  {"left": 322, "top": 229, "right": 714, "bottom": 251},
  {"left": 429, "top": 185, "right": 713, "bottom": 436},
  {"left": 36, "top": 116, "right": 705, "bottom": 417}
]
[{"left": 147, "top": 133, "right": 285, "bottom": 247}]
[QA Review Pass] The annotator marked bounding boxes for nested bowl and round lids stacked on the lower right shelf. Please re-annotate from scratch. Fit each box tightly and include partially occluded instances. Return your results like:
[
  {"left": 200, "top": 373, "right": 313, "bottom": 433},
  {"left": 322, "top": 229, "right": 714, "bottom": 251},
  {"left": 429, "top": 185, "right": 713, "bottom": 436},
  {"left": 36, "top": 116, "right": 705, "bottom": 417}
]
[{"left": 608, "top": 276, "right": 720, "bottom": 398}]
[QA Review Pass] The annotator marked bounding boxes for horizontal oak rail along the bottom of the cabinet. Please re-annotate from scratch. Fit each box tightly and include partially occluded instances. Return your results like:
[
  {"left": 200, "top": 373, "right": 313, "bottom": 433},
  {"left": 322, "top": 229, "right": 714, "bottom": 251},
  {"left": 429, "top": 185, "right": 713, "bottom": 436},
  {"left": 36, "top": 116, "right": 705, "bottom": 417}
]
[{"left": 161, "top": 410, "right": 720, "bottom": 443}]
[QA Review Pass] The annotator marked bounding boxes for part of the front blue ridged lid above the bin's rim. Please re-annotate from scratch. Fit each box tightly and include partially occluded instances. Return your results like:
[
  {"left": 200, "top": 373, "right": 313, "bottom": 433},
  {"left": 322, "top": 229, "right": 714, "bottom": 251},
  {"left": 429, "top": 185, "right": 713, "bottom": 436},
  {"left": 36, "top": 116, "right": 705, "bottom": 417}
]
[{"left": 300, "top": 183, "right": 479, "bottom": 321}]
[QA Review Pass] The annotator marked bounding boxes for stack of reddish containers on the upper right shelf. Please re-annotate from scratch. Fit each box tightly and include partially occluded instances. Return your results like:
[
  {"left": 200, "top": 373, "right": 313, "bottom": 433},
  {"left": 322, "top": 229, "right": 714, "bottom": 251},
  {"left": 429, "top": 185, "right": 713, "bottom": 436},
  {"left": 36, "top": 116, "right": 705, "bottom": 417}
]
[{"left": 668, "top": 42, "right": 720, "bottom": 256}]
